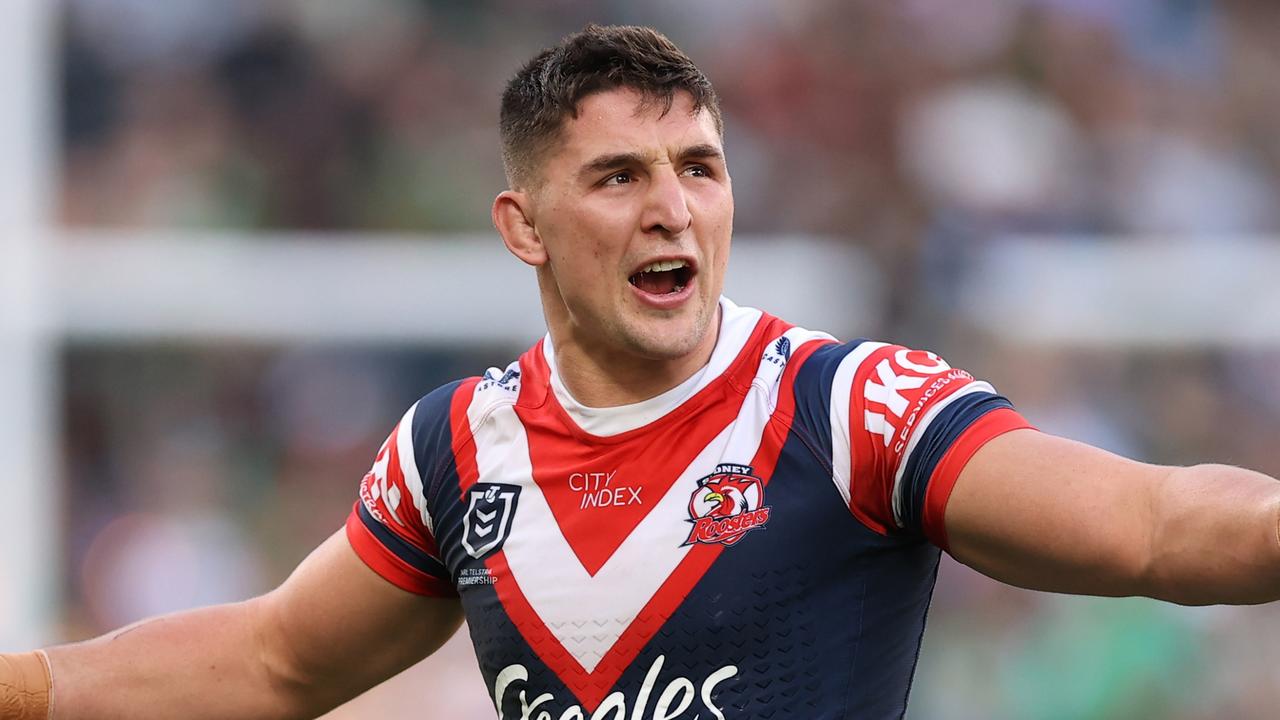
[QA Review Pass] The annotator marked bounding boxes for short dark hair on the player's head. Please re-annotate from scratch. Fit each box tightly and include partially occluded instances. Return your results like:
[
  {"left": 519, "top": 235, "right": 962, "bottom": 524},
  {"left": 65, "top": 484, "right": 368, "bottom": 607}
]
[{"left": 499, "top": 23, "right": 724, "bottom": 188}]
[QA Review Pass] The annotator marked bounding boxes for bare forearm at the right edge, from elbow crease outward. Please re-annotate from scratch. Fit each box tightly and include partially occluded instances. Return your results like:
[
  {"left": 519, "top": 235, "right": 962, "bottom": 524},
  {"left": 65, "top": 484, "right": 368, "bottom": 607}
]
[{"left": 1147, "top": 465, "right": 1280, "bottom": 605}]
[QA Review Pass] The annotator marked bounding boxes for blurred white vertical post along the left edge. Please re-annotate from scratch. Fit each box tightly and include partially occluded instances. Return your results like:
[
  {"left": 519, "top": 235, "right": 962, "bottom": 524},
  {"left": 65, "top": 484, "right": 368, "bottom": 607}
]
[{"left": 0, "top": 0, "right": 60, "bottom": 652}]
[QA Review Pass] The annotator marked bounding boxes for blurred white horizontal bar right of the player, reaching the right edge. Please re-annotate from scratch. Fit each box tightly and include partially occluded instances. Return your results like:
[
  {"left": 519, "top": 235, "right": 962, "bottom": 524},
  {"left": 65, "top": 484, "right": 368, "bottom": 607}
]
[{"left": 960, "top": 237, "right": 1280, "bottom": 348}]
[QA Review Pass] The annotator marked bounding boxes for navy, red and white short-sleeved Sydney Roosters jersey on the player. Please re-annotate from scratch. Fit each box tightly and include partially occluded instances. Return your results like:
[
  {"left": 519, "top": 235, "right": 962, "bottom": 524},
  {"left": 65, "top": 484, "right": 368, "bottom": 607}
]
[{"left": 347, "top": 300, "right": 1027, "bottom": 720}]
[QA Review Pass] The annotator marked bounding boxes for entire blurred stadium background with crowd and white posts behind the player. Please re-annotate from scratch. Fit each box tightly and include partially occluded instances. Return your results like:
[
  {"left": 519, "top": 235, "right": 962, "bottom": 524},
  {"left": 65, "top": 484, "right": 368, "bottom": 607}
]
[{"left": 0, "top": 0, "right": 1280, "bottom": 720}]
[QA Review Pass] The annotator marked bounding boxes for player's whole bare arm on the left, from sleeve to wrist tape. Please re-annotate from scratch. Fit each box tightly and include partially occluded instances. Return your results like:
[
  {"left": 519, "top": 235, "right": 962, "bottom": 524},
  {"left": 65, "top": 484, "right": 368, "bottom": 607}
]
[{"left": 49, "top": 532, "right": 461, "bottom": 720}]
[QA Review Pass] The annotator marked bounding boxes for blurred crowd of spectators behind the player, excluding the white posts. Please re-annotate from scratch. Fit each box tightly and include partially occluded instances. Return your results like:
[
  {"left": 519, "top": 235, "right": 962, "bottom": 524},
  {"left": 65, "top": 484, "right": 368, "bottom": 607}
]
[{"left": 59, "top": 0, "right": 1280, "bottom": 720}]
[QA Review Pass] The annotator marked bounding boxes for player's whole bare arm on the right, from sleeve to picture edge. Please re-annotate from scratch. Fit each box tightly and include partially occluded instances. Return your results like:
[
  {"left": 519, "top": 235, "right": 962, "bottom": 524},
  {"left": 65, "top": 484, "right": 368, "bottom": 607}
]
[{"left": 946, "top": 430, "right": 1280, "bottom": 605}]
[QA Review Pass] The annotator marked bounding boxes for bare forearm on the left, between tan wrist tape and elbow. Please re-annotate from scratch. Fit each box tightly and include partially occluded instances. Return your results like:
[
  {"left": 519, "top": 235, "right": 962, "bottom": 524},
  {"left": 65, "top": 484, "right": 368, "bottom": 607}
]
[{"left": 47, "top": 598, "right": 324, "bottom": 720}]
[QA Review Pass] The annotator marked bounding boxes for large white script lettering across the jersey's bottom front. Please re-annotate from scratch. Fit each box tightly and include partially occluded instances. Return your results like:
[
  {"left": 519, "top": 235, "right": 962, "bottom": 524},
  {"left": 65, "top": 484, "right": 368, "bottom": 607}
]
[{"left": 493, "top": 655, "right": 737, "bottom": 720}]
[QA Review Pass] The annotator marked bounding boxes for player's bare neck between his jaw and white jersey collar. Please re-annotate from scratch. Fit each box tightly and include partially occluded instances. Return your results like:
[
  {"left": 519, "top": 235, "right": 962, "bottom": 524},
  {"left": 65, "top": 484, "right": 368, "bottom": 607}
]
[{"left": 550, "top": 310, "right": 719, "bottom": 407}]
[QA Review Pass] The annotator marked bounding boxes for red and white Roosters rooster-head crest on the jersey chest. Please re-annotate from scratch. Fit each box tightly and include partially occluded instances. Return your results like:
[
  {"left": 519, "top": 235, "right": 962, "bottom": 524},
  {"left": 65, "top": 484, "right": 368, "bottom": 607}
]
[{"left": 684, "top": 462, "right": 769, "bottom": 544}]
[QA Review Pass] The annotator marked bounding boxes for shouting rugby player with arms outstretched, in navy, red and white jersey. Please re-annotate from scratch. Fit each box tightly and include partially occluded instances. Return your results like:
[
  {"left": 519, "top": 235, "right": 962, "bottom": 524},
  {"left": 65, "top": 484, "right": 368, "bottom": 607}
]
[{"left": 0, "top": 26, "right": 1280, "bottom": 720}]
